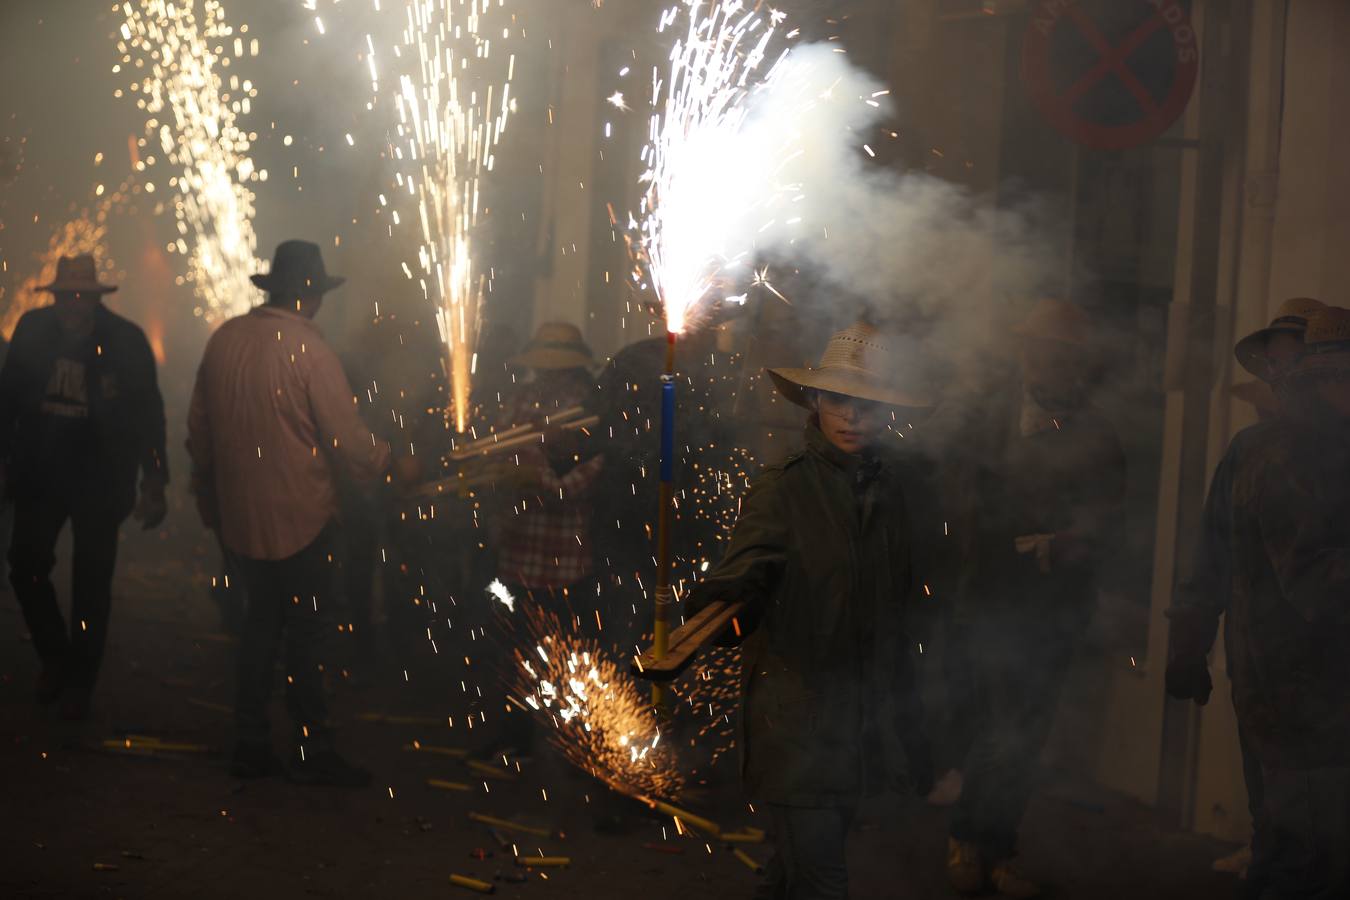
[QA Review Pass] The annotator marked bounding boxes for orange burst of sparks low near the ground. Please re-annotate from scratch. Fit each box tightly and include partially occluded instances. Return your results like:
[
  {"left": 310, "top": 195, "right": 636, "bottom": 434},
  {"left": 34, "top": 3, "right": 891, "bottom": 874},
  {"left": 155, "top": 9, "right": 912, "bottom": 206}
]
[{"left": 514, "top": 606, "right": 684, "bottom": 800}]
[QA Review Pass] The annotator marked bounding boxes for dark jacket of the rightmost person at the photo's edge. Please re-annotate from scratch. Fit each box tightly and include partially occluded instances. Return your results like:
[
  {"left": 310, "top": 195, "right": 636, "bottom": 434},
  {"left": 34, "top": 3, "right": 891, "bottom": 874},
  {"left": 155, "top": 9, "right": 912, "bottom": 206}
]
[{"left": 1227, "top": 422, "right": 1350, "bottom": 769}]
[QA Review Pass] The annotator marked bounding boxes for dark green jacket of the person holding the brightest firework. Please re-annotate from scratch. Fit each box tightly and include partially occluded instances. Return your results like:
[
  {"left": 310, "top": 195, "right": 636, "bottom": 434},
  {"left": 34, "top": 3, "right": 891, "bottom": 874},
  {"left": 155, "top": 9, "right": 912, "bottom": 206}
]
[{"left": 690, "top": 426, "right": 942, "bottom": 807}]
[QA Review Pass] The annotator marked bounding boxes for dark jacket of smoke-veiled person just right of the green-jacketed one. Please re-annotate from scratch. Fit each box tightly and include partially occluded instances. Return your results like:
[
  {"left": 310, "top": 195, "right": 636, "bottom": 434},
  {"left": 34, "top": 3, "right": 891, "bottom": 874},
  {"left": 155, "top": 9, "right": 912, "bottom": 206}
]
[{"left": 948, "top": 385, "right": 1125, "bottom": 633}]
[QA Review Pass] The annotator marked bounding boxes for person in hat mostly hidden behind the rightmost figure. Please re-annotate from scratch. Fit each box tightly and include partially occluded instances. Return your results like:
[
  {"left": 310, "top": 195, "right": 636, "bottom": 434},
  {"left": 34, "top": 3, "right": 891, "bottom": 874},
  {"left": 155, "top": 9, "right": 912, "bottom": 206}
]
[{"left": 1166, "top": 297, "right": 1326, "bottom": 885}]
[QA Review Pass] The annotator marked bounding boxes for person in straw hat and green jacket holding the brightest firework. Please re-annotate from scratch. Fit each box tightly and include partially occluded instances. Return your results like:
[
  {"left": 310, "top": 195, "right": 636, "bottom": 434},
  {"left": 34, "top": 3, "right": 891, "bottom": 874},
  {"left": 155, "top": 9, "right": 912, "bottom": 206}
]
[{"left": 686, "top": 324, "right": 941, "bottom": 900}]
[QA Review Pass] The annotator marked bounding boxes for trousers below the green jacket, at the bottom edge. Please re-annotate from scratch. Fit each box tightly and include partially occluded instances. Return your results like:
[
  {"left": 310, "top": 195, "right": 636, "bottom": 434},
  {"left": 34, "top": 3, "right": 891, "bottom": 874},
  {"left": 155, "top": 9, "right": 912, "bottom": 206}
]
[{"left": 755, "top": 804, "right": 856, "bottom": 900}]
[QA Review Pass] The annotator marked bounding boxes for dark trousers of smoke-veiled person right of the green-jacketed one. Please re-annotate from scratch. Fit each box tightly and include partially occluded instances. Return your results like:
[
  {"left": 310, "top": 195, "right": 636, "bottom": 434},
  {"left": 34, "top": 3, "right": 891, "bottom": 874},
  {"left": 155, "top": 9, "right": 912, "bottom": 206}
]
[{"left": 950, "top": 613, "right": 1073, "bottom": 862}]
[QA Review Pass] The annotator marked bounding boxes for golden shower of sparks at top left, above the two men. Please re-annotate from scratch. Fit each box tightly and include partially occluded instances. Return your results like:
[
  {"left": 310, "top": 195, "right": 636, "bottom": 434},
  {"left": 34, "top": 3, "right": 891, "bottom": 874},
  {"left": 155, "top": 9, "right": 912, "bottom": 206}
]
[{"left": 112, "top": 0, "right": 267, "bottom": 322}]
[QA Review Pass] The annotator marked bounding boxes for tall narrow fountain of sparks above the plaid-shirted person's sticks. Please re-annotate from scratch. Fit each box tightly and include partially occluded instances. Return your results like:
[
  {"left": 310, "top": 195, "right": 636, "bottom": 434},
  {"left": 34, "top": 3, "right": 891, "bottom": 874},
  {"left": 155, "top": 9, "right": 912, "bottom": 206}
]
[{"left": 348, "top": 0, "right": 516, "bottom": 433}]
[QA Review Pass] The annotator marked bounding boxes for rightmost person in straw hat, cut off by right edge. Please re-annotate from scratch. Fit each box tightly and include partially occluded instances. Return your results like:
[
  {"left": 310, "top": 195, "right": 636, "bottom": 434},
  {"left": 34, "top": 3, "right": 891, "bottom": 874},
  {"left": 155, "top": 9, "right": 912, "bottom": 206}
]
[{"left": 1197, "top": 308, "right": 1350, "bottom": 899}]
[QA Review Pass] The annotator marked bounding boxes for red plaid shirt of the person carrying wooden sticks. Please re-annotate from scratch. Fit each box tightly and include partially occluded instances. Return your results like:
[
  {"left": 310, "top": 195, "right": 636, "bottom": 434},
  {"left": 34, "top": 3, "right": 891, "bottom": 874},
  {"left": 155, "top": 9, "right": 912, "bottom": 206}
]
[{"left": 497, "top": 380, "right": 605, "bottom": 588}]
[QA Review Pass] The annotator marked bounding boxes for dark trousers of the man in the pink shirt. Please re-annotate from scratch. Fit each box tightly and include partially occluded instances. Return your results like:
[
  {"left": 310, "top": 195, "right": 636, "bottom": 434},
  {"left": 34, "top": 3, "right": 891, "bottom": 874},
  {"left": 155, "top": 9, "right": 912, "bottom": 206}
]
[{"left": 235, "top": 525, "right": 336, "bottom": 749}]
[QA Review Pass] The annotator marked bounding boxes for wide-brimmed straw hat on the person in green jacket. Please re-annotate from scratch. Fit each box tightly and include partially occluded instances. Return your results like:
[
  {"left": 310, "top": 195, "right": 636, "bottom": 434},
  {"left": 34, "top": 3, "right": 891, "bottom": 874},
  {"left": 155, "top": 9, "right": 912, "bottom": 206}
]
[{"left": 765, "top": 322, "right": 933, "bottom": 407}]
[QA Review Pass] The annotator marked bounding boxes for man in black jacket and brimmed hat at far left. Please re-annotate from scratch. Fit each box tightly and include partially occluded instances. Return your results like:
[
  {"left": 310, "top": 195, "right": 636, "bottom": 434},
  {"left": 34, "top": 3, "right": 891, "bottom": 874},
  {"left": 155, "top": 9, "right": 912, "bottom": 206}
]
[{"left": 0, "top": 255, "right": 169, "bottom": 719}]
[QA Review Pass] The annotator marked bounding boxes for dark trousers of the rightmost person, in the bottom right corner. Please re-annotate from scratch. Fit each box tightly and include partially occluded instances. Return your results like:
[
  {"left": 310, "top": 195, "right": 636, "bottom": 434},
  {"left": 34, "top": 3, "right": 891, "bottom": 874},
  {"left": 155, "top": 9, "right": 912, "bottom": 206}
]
[{"left": 1247, "top": 766, "right": 1350, "bottom": 900}]
